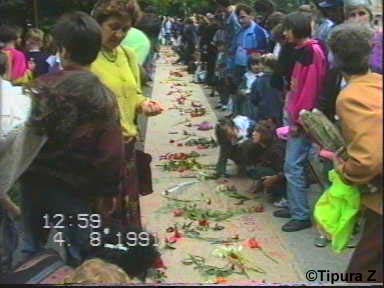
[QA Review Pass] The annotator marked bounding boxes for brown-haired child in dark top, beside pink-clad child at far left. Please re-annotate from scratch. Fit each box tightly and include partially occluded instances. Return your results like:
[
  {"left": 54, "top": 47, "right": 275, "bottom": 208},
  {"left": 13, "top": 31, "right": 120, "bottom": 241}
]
[{"left": 25, "top": 28, "right": 49, "bottom": 78}]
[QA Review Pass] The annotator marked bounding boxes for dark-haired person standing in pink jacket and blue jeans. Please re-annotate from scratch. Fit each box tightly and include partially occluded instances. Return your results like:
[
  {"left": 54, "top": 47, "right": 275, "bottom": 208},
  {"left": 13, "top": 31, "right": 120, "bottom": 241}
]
[{"left": 274, "top": 12, "right": 328, "bottom": 232}]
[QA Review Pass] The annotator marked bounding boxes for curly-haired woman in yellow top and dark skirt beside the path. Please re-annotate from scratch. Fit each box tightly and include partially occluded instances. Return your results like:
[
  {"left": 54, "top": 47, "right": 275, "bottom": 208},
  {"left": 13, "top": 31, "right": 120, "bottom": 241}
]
[{"left": 91, "top": 0, "right": 163, "bottom": 227}]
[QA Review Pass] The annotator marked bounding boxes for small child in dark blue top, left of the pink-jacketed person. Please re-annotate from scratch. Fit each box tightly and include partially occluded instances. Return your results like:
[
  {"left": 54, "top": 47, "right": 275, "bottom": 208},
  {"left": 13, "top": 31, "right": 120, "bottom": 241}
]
[{"left": 250, "top": 55, "right": 284, "bottom": 125}]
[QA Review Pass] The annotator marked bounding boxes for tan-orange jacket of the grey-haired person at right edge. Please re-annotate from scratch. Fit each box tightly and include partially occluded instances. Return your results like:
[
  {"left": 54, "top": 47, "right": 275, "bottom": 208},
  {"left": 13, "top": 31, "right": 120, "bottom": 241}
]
[{"left": 336, "top": 73, "right": 383, "bottom": 215}]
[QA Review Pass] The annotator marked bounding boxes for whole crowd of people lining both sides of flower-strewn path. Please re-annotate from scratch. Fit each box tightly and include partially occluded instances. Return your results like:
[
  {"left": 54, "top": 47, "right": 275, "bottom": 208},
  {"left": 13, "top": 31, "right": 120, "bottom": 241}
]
[{"left": 0, "top": 0, "right": 383, "bottom": 282}]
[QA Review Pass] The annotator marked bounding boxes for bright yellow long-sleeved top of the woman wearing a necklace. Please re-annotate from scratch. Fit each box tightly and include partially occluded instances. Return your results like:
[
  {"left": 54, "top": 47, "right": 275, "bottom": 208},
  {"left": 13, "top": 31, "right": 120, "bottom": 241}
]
[{"left": 91, "top": 46, "right": 147, "bottom": 137}]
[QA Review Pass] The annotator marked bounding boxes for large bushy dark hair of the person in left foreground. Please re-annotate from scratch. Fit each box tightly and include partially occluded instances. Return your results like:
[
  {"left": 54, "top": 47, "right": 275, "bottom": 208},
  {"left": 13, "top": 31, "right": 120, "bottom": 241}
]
[{"left": 28, "top": 71, "right": 119, "bottom": 143}]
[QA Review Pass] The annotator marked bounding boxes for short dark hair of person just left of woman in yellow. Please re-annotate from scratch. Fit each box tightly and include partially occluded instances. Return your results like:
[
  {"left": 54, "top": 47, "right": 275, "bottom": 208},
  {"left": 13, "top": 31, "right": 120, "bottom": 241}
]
[{"left": 53, "top": 12, "right": 102, "bottom": 66}]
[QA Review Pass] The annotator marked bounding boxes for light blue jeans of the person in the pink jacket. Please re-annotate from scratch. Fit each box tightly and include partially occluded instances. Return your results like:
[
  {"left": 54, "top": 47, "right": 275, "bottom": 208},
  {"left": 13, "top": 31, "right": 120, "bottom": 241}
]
[{"left": 284, "top": 134, "right": 312, "bottom": 220}]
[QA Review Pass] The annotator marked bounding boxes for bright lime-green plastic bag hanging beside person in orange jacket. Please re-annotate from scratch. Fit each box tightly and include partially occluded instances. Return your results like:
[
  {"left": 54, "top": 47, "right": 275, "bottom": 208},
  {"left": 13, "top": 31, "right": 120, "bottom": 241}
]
[{"left": 314, "top": 170, "right": 361, "bottom": 253}]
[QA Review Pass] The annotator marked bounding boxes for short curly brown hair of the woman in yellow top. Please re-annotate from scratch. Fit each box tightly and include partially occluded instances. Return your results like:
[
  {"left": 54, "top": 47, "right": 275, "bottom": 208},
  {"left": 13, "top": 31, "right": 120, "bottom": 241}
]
[{"left": 91, "top": 0, "right": 142, "bottom": 26}]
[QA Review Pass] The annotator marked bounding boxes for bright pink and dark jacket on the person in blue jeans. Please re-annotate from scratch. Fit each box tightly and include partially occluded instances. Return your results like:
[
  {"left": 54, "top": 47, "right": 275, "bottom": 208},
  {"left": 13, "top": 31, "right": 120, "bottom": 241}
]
[{"left": 287, "top": 39, "right": 328, "bottom": 124}]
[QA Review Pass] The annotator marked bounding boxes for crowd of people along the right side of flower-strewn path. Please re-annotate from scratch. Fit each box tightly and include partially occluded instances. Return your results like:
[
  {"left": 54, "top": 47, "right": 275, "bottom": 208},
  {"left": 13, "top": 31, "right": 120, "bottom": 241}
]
[{"left": 158, "top": 0, "right": 383, "bottom": 282}]
